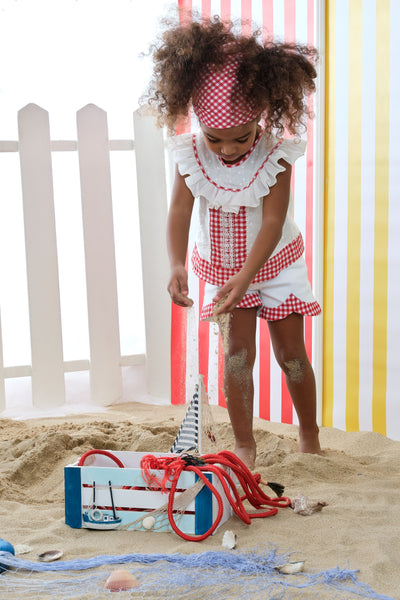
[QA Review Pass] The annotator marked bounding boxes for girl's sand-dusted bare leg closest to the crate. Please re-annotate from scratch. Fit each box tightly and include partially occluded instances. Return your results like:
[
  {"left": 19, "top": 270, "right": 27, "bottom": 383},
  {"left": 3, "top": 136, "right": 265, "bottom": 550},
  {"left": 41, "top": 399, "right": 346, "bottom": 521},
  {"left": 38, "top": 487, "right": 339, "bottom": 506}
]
[{"left": 224, "top": 308, "right": 257, "bottom": 469}]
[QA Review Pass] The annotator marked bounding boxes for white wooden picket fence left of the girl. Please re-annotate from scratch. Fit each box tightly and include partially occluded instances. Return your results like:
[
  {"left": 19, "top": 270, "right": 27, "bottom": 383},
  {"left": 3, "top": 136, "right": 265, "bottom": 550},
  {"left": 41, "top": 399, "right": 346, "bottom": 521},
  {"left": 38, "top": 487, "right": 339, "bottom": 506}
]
[{"left": 0, "top": 104, "right": 170, "bottom": 410}]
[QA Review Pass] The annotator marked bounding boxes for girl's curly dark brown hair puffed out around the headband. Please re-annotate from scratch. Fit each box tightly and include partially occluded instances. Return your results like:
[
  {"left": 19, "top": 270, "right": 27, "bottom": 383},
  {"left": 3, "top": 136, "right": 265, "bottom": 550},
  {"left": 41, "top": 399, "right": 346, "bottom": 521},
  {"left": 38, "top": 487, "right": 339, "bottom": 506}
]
[{"left": 141, "top": 17, "right": 317, "bottom": 135}]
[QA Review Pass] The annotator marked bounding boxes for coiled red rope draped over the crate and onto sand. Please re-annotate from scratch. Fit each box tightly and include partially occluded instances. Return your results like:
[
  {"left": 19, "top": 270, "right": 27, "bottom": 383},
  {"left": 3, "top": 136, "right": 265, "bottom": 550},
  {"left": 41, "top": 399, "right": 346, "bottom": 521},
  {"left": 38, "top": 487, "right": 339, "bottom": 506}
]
[{"left": 140, "top": 450, "right": 290, "bottom": 542}]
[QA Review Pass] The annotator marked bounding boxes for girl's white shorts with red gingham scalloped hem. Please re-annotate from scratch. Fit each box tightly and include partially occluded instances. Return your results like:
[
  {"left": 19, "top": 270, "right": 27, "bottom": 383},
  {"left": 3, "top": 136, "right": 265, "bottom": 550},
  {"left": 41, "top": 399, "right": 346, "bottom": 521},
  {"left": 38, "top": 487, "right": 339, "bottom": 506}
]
[{"left": 200, "top": 256, "right": 321, "bottom": 321}]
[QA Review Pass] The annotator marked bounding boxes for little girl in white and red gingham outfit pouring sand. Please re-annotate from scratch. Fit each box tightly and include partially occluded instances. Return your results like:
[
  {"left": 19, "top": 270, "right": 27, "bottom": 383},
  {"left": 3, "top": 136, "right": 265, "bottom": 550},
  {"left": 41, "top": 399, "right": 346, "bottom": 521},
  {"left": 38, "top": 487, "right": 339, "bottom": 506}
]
[{"left": 147, "top": 17, "right": 321, "bottom": 469}]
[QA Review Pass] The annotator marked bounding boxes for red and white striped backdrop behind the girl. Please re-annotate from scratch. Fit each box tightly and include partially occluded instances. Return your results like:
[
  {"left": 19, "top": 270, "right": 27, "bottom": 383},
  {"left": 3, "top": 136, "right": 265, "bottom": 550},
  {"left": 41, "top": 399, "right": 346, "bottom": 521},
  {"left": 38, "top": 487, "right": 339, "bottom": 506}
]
[{"left": 171, "top": 0, "right": 321, "bottom": 423}]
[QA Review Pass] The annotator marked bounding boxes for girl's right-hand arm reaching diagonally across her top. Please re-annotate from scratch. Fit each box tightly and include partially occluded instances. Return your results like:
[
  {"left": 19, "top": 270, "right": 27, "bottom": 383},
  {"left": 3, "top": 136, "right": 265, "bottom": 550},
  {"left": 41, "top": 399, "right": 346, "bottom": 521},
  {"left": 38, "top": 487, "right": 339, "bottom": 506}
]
[{"left": 214, "top": 159, "right": 292, "bottom": 314}]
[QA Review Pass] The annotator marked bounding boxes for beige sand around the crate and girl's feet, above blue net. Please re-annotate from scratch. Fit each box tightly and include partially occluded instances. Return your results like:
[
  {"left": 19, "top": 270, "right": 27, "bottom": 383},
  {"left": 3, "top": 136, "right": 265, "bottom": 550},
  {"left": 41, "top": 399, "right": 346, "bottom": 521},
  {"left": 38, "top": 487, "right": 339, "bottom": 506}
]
[{"left": 0, "top": 403, "right": 400, "bottom": 598}]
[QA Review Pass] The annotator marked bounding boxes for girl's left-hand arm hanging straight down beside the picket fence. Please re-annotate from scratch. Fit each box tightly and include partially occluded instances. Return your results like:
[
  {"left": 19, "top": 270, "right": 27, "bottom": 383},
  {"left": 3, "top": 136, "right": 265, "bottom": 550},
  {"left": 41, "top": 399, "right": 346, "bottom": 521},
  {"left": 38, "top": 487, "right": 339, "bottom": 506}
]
[{"left": 167, "top": 169, "right": 194, "bottom": 306}]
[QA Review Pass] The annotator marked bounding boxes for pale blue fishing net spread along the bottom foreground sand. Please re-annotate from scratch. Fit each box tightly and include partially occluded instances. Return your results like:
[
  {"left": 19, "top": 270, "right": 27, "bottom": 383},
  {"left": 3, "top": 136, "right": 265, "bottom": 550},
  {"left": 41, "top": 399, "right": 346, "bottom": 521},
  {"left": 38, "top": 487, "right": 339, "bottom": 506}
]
[{"left": 0, "top": 547, "right": 395, "bottom": 600}]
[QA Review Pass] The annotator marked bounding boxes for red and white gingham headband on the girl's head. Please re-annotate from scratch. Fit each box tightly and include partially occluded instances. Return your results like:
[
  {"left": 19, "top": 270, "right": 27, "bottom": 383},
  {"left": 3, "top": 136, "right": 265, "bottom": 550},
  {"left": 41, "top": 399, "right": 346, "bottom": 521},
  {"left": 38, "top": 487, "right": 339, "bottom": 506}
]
[{"left": 192, "top": 54, "right": 260, "bottom": 129}]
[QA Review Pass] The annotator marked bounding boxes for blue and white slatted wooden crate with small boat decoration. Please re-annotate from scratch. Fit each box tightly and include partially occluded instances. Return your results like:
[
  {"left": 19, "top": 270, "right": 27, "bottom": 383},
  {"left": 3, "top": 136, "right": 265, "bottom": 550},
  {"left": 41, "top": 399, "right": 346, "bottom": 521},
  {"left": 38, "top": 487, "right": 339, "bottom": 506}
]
[{"left": 64, "top": 451, "right": 232, "bottom": 535}]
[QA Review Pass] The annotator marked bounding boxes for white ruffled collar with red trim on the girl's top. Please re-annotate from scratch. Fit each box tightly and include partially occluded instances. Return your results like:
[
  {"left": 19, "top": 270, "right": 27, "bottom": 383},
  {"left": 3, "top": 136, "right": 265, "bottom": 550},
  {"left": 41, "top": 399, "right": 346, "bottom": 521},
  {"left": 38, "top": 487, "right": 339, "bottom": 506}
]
[{"left": 169, "top": 132, "right": 306, "bottom": 213}]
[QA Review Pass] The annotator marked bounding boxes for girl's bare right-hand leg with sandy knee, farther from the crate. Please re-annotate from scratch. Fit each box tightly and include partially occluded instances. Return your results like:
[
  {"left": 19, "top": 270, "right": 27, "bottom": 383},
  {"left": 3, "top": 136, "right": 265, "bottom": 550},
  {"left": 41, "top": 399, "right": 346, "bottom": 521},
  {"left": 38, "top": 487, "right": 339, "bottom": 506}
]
[{"left": 268, "top": 313, "right": 321, "bottom": 454}]
